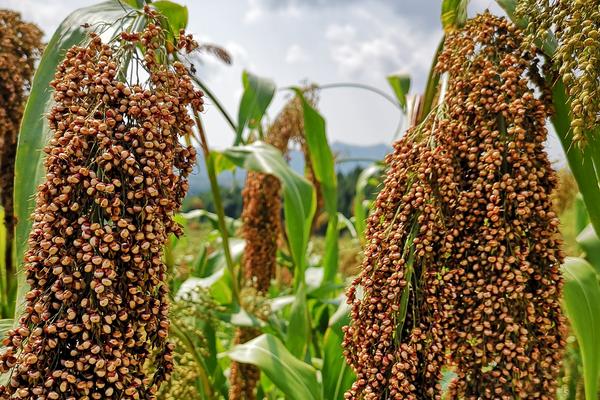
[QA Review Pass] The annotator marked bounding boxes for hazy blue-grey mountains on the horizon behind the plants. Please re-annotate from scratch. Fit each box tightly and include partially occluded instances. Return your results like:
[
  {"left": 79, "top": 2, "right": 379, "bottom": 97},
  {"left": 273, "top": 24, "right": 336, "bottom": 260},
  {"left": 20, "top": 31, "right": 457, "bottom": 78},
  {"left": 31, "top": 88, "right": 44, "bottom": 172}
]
[{"left": 189, "top": 142, "right": 392, "bottom": 194}]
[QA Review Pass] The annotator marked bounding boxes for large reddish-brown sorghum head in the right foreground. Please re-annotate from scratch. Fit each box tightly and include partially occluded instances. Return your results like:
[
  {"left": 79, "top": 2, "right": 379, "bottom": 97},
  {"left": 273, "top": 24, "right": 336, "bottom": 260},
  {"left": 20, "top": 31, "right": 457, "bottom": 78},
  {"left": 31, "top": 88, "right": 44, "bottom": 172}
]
[{"left": 344, "top": 14, "right": 564, "bottom": 400}]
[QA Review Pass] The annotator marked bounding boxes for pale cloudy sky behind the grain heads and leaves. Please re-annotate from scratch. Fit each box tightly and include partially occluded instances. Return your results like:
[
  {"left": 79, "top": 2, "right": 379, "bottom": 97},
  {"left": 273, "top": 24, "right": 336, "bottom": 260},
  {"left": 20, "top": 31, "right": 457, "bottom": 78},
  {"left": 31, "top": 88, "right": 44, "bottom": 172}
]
[{"left": 0, "top": 0, "right": 554, "bottom": 162}]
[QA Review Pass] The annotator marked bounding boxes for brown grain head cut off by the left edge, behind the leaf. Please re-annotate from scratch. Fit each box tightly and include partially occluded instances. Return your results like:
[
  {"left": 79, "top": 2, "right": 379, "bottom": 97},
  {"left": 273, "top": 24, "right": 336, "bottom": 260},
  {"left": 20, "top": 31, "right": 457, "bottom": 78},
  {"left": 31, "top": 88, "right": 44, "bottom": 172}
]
[{"left": 0, "top": 10, "right": 43, "bottom": 294}]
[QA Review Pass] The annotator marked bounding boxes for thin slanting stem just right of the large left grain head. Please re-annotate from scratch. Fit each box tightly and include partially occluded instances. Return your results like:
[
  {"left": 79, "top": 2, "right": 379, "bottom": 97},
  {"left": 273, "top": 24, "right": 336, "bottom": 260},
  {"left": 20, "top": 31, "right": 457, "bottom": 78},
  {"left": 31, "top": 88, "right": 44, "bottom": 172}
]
[{"left": 194, "top": 108, "right": 241, "bottom": 306}]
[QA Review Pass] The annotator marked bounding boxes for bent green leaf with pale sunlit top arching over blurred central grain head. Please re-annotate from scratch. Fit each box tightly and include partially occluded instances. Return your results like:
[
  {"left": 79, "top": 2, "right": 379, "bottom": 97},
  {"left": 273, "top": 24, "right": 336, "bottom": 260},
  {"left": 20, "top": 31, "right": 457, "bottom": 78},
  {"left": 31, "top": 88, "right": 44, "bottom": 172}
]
[{"left": 223, "top": 141, "right": 316, "bottom": 277}]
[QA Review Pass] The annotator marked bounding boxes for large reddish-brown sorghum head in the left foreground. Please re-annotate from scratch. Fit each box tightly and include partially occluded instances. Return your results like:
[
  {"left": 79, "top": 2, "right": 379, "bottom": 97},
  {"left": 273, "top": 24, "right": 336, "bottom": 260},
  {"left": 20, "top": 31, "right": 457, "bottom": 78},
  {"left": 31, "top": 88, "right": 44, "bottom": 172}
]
[{"left": 0, "top": 8, "right": 202, "bottom": 400}]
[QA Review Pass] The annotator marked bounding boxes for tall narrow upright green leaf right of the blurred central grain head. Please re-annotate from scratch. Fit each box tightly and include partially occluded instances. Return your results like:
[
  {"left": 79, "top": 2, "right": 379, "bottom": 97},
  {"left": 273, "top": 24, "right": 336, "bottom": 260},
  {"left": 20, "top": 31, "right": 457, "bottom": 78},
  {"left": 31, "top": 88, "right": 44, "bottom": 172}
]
[{"left": 294, "top": 88, "right": 339, "bottom": 283}]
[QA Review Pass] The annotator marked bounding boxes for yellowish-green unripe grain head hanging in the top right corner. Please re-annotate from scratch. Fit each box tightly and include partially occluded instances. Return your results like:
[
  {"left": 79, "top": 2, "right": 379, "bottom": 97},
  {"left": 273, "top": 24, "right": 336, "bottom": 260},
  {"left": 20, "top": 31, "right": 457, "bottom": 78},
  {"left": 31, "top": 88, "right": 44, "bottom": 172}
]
[{"left": 517, "top": 0, "right": 600, "bottom": 144}]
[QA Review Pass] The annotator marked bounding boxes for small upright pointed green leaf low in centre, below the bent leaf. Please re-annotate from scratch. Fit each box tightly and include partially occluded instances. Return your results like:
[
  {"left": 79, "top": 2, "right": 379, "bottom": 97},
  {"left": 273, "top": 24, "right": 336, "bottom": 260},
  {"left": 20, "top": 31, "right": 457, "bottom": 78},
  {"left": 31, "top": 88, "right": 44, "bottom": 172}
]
[{"left": 285, "top": 283, "right": 312, "bottom": 359}]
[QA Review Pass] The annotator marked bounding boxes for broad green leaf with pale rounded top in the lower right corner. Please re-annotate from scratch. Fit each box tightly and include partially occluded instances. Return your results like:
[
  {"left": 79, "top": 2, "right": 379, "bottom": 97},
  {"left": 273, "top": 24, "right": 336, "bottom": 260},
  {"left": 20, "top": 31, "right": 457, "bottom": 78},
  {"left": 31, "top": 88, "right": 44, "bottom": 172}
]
[{"left": 562, "top": 257, "right": 600, "bottom": 400}]
